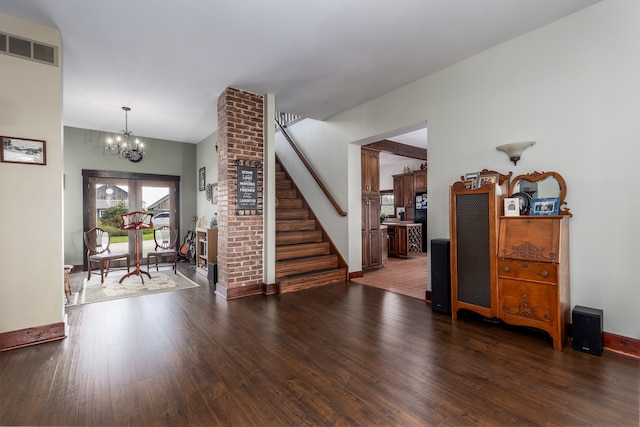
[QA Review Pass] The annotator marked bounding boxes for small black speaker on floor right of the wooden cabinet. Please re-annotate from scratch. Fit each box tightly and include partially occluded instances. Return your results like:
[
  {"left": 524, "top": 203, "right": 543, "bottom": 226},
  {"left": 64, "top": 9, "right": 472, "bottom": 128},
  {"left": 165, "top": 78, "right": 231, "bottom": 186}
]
[{"left": 571, "top": 305, "right": 603, "bottom": 356}]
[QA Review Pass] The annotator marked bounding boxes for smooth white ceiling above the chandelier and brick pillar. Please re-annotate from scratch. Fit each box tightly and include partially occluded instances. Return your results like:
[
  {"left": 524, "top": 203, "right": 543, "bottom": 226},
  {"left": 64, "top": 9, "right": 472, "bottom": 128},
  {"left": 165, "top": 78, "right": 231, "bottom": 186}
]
[{"left": 0, "top": 0, "right": 598, "bottom": 143}]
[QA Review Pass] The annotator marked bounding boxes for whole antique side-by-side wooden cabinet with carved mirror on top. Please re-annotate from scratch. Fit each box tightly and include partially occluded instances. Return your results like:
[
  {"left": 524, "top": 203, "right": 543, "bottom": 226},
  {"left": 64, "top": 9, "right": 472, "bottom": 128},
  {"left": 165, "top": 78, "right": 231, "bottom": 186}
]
[{"left": 450, "top": 170, "right": 571, "bottom": 350}]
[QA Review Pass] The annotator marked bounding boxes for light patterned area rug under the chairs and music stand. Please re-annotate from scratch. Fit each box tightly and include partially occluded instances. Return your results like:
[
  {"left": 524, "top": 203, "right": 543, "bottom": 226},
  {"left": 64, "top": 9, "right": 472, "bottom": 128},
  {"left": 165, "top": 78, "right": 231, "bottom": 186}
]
[{"left": 80, "top": 270, "right": 198, "bottom": 304}]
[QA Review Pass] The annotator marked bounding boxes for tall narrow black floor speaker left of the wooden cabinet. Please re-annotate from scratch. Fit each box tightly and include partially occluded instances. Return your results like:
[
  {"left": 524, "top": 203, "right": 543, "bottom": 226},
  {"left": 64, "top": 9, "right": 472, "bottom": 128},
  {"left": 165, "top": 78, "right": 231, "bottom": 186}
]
[{"left": 431, "top": 239, "right": 451, "bottom": 314}]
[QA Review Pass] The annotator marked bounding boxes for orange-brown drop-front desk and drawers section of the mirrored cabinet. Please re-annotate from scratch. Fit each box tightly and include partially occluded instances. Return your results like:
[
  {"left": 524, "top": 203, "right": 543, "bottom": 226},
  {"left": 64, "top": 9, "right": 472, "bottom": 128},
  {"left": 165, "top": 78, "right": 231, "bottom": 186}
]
[{"left": 498, "top": 216, "right": 570, "bottom": 350}]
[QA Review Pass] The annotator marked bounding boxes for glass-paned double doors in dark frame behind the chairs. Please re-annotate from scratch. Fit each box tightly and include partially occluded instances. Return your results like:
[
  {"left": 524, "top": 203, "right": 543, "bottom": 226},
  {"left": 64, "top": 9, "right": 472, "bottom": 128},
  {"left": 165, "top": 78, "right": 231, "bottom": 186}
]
[{"left": 82, "top": 170, "right": 180, "bottom": 269}]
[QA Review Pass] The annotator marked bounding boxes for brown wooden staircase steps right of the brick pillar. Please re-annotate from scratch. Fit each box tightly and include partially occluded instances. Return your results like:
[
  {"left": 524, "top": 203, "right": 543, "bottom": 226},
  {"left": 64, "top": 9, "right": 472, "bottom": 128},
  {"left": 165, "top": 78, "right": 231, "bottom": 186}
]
[{"left": 276, "top": 162, "right": 347, "bottom": 293}]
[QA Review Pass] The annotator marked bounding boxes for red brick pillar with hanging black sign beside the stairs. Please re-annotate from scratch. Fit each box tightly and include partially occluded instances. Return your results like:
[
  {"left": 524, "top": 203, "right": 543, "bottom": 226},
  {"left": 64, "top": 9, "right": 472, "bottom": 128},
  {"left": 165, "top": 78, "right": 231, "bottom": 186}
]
[{"left": 216, "top": 88, "right": 264, "bottom": 299}]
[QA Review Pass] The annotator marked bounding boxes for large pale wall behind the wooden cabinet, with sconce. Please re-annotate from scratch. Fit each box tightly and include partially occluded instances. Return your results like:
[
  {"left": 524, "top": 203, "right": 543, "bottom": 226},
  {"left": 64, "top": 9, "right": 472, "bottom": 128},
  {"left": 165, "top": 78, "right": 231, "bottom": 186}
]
[{"left": 280, "top": 0, "right": 640, "bottom": 339}]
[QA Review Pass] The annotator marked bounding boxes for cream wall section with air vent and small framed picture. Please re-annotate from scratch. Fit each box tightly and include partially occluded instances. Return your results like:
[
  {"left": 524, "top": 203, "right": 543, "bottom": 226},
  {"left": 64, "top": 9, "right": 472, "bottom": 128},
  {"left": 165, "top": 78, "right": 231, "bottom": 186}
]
[{"left": 0, "top": 14, "right": 64, "bottom": 333}]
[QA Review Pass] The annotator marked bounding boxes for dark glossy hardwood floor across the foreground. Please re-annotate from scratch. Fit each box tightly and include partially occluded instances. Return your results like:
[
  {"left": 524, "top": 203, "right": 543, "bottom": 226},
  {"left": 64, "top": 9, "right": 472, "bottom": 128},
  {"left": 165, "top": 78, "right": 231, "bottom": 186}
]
[{"left": 0, "top": 264, "right": 640, "bottom": 426}]
